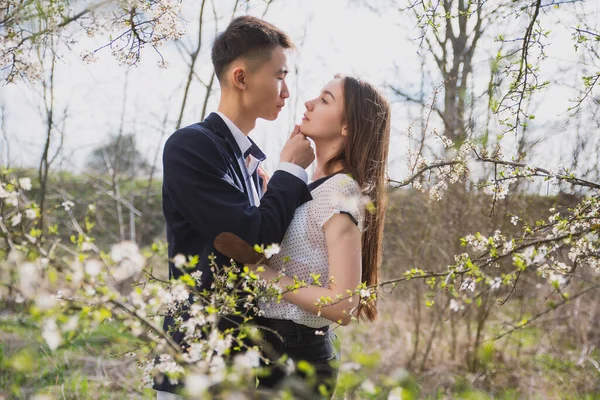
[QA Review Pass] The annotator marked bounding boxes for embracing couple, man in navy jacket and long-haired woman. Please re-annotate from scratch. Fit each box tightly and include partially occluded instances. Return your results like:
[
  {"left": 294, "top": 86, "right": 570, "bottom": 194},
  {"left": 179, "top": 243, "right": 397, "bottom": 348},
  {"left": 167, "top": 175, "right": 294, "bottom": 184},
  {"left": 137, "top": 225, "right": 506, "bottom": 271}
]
[{"left": 154, "top": 16, "right": 390, "bottom": 399}]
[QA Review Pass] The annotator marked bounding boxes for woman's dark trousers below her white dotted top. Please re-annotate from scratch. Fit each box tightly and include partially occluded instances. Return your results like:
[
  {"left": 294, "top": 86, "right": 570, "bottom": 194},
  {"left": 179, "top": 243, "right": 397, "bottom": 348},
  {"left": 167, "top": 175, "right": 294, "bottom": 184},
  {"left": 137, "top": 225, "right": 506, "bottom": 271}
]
[{"left": 255, "top": 317, "right": 340, "bottom": 399}]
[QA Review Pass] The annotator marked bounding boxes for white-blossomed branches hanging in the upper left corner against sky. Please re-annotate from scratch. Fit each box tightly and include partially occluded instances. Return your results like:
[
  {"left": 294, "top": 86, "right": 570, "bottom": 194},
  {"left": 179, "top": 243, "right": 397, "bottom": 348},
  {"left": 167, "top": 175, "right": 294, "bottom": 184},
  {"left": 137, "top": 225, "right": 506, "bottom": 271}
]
[{"left": 0, "top": 0, "right": 185, "bottom": 83}]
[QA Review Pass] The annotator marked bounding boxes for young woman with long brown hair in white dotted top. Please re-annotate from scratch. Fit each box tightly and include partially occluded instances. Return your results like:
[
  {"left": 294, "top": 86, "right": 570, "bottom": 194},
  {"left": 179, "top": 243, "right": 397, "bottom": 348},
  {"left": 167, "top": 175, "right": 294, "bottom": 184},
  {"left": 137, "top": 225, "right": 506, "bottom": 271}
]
[{"left": 258, "top": 75, "right": 390, "bottom": 398}]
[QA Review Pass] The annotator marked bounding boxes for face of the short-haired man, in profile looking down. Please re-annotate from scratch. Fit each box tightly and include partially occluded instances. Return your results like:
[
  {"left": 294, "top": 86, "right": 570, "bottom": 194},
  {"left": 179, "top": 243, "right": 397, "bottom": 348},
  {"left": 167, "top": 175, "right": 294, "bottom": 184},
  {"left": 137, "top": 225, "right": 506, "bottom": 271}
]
[{"left": 243, "top": 46, "right": 290, "bottom": 121}]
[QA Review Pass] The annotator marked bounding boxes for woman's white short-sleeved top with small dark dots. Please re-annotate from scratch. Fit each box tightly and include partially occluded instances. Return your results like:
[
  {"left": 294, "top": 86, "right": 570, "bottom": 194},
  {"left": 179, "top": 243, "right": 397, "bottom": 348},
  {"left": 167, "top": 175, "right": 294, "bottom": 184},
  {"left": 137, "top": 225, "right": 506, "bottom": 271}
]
[{"left": 259, "top": 174, "right": 365, "bottom": 328}]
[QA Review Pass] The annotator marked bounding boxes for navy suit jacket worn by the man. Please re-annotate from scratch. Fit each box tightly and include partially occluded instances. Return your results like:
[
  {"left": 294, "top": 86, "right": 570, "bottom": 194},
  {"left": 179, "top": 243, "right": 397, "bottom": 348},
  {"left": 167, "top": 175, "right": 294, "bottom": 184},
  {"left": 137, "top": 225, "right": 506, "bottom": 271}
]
[{"left": 154, "top": 113, "right": 312, "bottom": 391}]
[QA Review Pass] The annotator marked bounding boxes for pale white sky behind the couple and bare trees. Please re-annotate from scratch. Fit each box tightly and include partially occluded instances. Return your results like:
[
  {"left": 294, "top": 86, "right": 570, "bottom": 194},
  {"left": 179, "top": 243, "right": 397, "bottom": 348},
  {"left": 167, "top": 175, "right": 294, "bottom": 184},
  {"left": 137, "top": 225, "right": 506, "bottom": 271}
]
[{"left": 0, "top": 0, "right": 600, "bottom": 184}]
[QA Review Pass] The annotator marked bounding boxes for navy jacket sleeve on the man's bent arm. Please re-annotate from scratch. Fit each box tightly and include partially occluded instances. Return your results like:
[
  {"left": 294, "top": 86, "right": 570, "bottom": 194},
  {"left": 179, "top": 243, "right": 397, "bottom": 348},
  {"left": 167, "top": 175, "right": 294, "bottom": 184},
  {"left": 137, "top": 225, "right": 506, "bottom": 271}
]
[{"left": 163, "top": 131, "right": 311, "bottom": 245}]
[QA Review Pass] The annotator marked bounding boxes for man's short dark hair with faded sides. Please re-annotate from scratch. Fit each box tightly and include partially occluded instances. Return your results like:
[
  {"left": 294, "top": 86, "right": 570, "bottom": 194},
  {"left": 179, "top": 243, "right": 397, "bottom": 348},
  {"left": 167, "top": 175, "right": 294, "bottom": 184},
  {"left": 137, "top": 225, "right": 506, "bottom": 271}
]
[{"left": 212, "top": 15, "right": 294, "bottom": 81}]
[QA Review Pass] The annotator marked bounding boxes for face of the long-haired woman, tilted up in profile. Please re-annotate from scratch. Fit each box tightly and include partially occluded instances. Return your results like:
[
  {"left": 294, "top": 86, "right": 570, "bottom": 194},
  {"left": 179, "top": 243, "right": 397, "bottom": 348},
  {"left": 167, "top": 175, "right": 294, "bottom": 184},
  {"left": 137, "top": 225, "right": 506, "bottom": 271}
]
[{"left": 300, "top": 78, "right": 345, "bottom": 141}]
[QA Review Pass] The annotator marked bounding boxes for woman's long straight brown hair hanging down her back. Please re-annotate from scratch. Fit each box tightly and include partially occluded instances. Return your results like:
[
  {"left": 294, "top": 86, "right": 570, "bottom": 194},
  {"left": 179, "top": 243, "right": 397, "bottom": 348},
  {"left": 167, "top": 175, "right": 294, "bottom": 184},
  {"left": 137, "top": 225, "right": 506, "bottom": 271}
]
[{"left": 324, "top": 74, "right": 391, "bottom": 321}]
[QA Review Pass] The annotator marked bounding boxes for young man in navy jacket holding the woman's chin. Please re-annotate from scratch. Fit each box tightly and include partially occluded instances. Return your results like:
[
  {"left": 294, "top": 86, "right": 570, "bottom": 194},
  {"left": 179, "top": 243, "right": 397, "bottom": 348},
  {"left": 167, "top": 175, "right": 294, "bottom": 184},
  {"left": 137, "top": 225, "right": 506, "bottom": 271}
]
[{"left": 154, "top": 16, "right": 315, "bottom": 398}]
